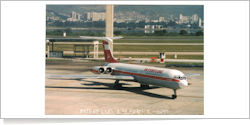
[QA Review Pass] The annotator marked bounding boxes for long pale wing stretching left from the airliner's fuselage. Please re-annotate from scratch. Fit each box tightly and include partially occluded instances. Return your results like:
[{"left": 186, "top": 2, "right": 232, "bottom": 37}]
[{"left": 47, "top": 75, "right": 134, "bottom": 81}]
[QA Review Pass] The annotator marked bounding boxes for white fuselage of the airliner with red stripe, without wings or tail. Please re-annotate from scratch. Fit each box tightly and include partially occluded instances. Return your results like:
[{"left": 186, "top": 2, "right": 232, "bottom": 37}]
[{"left": 93, "top": 63, "right": 188, "bottom": 89}]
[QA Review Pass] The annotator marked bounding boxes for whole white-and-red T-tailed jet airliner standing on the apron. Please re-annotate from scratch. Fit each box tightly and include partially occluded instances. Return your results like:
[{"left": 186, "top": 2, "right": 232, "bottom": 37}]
[{"left": 50, "top": 36, "right": 197, "bottom": 99}]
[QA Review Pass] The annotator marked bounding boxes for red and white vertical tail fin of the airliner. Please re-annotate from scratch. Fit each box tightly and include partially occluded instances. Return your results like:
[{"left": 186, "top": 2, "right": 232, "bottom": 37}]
[{"left": 102, "top": 40, "right": 117, "bottom": 63}]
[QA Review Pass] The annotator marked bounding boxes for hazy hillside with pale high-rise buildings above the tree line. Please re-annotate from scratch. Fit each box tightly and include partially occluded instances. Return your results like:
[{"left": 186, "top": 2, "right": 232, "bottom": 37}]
[{"left": 46, "top": 5, "right": 203, "bottom": 24}]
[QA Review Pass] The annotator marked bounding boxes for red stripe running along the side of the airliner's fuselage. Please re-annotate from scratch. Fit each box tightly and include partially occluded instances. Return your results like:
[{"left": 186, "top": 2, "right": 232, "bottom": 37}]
[{"left": 114, "top": 70, "right": 180, "bottom": 82}]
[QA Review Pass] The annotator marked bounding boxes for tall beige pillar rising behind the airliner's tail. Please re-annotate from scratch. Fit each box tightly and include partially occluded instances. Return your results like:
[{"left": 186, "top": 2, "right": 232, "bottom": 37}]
[{"left": 105, "top": 5, "right": 114, "bottom": 52}]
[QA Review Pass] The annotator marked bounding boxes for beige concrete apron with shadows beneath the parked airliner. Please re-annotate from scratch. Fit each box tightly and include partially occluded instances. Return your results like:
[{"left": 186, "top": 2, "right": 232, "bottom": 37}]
[{"left": 45, "top": 61, "right": 204, "bottom": 115}]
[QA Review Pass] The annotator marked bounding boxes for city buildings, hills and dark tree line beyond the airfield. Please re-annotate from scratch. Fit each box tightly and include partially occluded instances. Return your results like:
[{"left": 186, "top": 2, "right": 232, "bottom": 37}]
[{"left": 46, "top": 5, "right": 204, "bottom": 35}]
